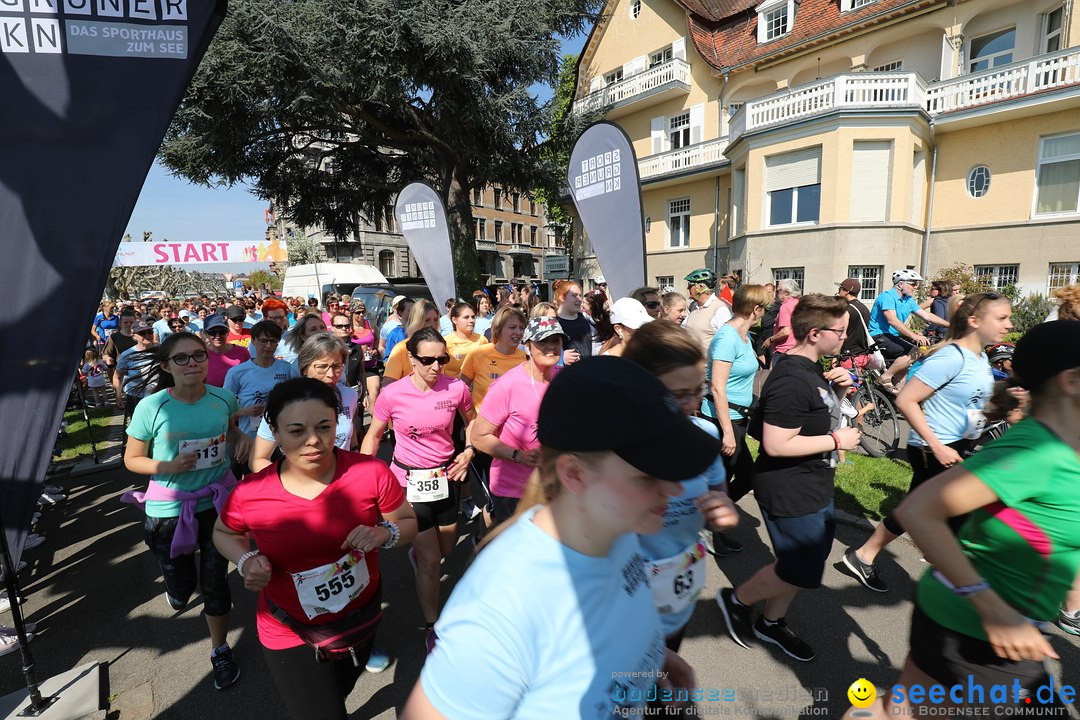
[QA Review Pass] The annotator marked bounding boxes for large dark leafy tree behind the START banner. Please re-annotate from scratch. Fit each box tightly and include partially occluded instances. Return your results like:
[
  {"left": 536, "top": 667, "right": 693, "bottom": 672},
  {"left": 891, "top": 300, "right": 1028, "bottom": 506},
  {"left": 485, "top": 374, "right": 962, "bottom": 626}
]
[{"left": 162, "top": 0, "right": 602, "bottom": 287}]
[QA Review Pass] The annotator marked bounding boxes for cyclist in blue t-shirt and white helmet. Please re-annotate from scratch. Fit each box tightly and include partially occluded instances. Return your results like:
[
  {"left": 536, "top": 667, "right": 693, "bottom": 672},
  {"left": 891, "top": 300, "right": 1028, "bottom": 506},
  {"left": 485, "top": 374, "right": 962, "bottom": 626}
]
[{"left": 869, "top": 269, "right": 948, "bottom": 393}]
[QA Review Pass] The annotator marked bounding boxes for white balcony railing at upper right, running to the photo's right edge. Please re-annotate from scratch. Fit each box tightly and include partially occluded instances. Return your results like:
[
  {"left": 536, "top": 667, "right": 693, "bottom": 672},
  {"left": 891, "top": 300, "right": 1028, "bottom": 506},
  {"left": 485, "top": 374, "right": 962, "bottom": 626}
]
[{"left": 927, "top": 47, "right": 1080, "bottom": 116}]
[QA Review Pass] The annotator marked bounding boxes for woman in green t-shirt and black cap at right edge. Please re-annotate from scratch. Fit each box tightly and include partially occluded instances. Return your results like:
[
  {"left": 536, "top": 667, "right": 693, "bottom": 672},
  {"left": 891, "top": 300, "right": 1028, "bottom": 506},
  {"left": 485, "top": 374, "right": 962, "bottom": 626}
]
[{"left": 842, "top": 321, "right": 1080, "bottom": 718}]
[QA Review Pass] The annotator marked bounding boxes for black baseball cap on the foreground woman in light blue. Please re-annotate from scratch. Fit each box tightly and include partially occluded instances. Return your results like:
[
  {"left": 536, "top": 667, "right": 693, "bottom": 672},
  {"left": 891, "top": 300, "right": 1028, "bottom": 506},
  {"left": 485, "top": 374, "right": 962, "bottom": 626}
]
[{"left": 537, "top": 357, "right": 720, "bottom": 480}]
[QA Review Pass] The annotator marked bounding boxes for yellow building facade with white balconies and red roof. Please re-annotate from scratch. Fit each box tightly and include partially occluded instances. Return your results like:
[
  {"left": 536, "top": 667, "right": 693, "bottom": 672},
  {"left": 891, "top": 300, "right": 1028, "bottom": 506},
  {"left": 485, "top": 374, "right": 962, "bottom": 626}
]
[{"left": 575, "top": 0, "right": 1080, "bottom": 300}]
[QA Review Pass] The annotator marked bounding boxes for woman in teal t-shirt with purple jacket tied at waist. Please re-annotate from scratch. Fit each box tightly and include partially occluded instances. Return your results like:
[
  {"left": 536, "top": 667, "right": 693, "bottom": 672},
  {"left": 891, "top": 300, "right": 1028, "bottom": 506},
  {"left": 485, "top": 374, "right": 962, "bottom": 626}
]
[{"left": 124, "top": 332, "right": 247, "bottom": 690}]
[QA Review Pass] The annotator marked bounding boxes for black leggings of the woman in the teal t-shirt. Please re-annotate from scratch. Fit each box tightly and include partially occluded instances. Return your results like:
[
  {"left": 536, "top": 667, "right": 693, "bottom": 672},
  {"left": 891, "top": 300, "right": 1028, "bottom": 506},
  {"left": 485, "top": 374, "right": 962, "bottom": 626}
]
[{"left": 143, "top": 507, "right": 232, "bottom": 616}]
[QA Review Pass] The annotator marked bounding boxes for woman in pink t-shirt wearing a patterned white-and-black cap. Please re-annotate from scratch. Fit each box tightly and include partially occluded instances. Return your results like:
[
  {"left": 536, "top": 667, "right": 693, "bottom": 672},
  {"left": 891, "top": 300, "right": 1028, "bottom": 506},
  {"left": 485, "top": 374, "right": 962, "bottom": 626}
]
[{"left": 472, "top": 317, "right": 567, "bottom": 524}]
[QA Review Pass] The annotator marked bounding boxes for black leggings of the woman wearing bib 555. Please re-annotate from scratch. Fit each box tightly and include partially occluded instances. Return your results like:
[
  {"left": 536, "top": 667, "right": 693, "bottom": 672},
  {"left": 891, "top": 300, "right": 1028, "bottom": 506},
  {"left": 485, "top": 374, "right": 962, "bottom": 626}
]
[{"left": 262, "top": 644, "right": 372, "bottom": 720}]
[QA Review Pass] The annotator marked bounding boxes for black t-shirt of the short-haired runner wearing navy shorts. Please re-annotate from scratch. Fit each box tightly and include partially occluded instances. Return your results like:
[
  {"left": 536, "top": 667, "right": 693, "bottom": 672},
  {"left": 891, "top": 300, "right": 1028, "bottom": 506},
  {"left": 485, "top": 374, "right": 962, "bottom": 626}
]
[{"left": 754, "top": 355, "right": 840, "bottom": 517}]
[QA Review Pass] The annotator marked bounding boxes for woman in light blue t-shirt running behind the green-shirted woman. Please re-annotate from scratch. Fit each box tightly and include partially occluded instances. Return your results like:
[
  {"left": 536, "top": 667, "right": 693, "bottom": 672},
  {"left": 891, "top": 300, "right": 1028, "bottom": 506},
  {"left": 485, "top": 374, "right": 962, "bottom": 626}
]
[{"left": 843, "top": 293, "right": 1012, "bottom": 593}]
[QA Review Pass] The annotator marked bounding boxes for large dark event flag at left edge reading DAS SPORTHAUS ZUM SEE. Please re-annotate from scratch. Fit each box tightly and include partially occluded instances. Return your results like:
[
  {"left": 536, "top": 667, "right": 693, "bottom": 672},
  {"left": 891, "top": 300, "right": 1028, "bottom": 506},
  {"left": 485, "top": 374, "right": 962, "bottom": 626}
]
[{"left": 0, "top": 0, "right": 226, "bottom": 562}]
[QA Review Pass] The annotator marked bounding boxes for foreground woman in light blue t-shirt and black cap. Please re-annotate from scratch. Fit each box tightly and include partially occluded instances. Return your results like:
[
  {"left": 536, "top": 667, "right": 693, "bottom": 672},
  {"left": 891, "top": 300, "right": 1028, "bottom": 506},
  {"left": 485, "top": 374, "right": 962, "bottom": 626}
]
[{"left": 402, "top": 357, "right": 719, "bottom": 719}]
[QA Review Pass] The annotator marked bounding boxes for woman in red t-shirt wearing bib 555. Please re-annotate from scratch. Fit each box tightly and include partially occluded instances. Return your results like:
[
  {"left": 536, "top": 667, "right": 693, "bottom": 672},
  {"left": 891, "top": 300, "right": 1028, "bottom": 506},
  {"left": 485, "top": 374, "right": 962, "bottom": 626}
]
[{"left": 214, "top": 378, "right": 416, "bottom": 720}]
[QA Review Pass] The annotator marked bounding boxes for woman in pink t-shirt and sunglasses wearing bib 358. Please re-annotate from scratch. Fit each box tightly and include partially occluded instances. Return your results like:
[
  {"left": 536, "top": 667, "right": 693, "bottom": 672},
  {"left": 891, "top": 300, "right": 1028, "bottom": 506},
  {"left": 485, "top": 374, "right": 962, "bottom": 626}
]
[{"left": 360, "top": 327, "right": 476, "bottom": 652}]
